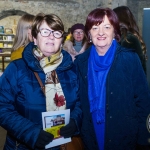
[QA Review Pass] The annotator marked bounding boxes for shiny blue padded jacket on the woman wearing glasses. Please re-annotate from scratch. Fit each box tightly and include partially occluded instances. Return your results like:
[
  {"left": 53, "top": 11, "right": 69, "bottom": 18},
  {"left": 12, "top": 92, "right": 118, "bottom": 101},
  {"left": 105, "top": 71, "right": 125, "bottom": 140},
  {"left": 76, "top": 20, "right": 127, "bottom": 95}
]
[{"left": 0, "top": 43, "right": 81, "bottom": 150}]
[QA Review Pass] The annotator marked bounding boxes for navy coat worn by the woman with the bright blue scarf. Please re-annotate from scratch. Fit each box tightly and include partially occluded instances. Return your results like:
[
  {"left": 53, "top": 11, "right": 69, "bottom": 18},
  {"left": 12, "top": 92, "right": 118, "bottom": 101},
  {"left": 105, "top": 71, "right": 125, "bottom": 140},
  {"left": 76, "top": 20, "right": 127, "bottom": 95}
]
[{"left": 75, "top": 42, "right": 150, "bottom": 150}]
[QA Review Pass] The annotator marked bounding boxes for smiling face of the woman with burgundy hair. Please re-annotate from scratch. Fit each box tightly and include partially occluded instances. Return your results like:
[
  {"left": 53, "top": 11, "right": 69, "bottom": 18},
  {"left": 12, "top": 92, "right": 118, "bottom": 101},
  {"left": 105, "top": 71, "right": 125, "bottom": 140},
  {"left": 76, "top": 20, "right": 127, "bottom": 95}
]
[{"left": 89, "top": 15, "right": 115, "bottom": 55}]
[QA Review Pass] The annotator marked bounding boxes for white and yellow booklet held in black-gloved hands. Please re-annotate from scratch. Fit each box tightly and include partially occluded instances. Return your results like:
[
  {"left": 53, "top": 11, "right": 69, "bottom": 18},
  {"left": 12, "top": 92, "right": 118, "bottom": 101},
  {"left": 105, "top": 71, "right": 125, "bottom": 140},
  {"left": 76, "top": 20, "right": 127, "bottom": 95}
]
[{"left": 42, "top": 109, "right": 71, "bottom": 149}]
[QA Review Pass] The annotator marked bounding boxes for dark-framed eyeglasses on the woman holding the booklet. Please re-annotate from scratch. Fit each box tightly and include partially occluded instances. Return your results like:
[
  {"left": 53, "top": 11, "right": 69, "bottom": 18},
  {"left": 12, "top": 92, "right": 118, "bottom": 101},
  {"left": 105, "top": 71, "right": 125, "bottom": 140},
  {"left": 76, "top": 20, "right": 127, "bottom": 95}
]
[{"left": 40, "top": 29, "right": 63, "bottom": 39}]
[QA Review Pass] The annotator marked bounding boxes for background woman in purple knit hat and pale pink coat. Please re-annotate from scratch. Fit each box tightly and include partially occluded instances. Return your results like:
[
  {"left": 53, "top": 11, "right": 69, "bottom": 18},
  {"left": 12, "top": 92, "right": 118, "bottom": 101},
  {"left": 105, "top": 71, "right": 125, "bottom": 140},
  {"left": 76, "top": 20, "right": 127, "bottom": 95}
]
[{"left": 63, "top": 23, "right": 87, "bottom": 61}]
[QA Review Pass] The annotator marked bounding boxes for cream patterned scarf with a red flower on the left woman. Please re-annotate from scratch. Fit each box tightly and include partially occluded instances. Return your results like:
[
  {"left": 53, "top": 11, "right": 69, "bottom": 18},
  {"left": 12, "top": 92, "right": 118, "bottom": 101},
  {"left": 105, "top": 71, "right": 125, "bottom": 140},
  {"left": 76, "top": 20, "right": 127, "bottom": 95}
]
[{"left": 33, "top": 48, "right": 66, "bottom": 111}]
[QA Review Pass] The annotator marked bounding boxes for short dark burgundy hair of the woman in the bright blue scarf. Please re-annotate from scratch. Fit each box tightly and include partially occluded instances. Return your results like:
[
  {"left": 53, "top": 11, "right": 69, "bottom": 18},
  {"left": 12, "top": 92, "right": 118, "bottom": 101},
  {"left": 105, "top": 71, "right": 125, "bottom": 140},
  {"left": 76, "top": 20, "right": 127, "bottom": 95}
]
[{"left": 85, "top": 8, "right": 121, "bottom": 41}]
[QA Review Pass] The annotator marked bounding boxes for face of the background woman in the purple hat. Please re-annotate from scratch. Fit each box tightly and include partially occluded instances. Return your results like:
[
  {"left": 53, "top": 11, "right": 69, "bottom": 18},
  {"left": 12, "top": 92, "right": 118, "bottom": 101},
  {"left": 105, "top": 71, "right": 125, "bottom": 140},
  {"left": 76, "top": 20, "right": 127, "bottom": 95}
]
[{"left": 73, "top": 29, "right": 84, "bottom": 42}]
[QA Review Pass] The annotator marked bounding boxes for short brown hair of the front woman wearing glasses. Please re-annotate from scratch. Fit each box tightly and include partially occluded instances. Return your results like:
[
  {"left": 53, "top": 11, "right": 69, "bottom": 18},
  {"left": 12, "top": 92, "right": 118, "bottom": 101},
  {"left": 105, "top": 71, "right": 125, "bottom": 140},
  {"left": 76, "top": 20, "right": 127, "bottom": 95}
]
[{"left": 31, "top": 13, "right": 64, "bottom": 38}]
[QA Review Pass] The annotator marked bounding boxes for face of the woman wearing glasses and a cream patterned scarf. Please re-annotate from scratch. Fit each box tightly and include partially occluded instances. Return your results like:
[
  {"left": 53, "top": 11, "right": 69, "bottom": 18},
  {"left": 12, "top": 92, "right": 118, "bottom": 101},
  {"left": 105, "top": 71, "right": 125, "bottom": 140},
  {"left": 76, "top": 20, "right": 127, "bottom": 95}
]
[{"left": 33, "top": 21, "right": 62, "bottom": 57}]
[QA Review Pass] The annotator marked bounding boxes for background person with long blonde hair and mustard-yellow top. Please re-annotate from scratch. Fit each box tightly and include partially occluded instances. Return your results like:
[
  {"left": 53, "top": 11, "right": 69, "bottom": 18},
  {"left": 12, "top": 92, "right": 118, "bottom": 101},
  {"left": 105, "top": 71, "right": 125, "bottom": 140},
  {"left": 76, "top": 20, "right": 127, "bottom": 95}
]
[{"left": 11, "top": 14, "right": 35, "bottom": 61}]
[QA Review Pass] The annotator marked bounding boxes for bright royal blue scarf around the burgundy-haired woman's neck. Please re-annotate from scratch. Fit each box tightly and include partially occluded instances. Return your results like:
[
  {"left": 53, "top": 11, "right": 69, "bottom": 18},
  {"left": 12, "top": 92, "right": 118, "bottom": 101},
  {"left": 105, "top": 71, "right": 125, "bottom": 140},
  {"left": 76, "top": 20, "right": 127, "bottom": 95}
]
[{"left": 88, "top": 40, "right": 116, "bottom": 123}]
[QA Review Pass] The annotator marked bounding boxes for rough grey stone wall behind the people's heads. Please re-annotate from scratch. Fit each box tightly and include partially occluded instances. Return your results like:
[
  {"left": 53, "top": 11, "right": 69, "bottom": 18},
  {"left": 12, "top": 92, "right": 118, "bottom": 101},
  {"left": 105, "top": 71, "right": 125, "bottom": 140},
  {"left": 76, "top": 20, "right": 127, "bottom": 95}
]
[{"left": 0, "top": 0, "right": 150, "bottom": 31}]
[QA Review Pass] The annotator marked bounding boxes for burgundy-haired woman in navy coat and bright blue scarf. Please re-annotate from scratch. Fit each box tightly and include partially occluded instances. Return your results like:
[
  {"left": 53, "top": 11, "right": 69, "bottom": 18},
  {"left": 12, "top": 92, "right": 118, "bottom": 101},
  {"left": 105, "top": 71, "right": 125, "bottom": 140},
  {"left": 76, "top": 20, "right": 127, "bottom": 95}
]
[{"left": 74, "top": 8, "right": 150, "bottom": 150}]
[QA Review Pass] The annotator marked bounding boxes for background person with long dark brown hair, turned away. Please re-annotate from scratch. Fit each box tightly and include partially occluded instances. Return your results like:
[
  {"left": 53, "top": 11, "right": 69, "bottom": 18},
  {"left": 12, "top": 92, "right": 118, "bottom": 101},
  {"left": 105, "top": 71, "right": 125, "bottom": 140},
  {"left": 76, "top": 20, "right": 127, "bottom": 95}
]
[{"left": 113, "top": 6, "right": 147, "bottom": 73}]
